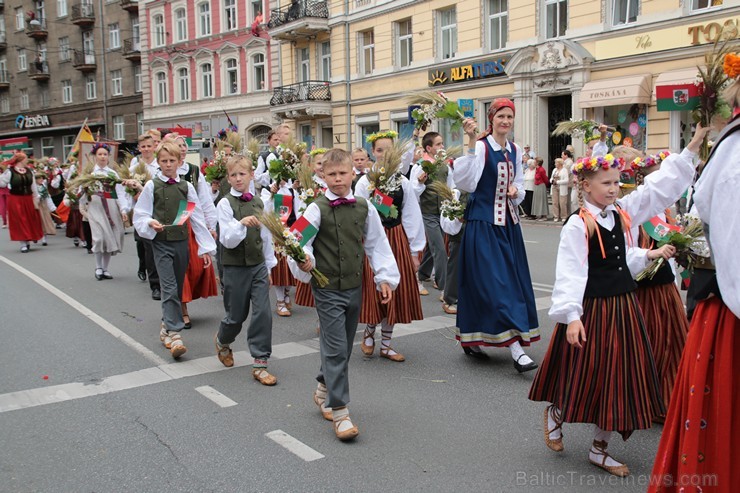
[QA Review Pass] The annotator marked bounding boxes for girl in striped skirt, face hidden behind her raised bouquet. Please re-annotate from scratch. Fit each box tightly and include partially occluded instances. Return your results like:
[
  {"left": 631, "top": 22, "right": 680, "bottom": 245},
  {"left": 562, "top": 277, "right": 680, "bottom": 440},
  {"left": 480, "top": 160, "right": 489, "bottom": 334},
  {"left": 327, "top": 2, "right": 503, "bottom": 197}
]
[{"left": 355, "top": 134, "right": 426, "bottom": 362}]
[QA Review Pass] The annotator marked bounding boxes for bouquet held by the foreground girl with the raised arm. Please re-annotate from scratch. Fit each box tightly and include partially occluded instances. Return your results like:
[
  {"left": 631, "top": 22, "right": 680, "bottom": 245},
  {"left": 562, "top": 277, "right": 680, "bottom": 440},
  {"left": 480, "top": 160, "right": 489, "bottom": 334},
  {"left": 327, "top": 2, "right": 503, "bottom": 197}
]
[{"left": 635, "top": 214, "right": 709, "bottom": 281}]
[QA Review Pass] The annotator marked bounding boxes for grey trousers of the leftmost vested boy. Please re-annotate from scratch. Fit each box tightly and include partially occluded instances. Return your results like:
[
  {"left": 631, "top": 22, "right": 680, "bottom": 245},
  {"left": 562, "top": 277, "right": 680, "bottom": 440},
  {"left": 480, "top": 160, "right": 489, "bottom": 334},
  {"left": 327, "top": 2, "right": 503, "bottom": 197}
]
[{"left": 152, "top": 240, "right": 190, "bottom": 332}]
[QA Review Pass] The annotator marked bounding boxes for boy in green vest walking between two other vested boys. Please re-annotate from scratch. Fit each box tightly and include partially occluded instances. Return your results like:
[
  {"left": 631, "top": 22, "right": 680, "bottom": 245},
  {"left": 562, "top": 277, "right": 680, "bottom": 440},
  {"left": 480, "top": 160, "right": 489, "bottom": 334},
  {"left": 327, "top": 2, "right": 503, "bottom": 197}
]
[{"left": 216, "top": 156, "right": 277, "bottom": 385}]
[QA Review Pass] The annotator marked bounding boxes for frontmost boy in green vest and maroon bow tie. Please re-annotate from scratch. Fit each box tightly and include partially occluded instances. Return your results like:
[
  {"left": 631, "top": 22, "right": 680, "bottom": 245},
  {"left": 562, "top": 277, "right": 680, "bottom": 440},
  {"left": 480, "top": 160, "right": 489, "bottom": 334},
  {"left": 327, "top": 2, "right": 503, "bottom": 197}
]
[{"left": 290, "top": 149, "right": 401, "bottom": 440}]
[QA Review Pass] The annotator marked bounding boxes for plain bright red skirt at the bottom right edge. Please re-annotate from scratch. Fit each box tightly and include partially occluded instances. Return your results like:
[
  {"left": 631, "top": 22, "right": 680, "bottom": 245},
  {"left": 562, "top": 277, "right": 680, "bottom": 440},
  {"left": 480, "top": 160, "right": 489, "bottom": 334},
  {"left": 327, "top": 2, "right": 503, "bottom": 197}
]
[{"left": 648, "top": 297, "right": 740, "bottom": 493}]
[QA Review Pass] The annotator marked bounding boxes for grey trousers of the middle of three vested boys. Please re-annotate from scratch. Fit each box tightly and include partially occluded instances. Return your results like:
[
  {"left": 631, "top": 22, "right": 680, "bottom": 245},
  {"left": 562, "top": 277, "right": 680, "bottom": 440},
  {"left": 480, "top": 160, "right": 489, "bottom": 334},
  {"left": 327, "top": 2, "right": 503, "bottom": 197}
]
[{"left": 218, "top": 262, "right": 272, "bottom": 360}]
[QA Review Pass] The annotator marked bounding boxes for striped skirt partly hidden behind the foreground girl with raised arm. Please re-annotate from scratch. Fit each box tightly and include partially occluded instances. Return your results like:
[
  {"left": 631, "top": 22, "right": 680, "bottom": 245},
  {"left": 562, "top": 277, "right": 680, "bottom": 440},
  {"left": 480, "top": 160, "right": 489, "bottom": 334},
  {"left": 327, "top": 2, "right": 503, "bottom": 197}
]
[{"left": 637, "top": 283, "right": 689, "bottom": 416}]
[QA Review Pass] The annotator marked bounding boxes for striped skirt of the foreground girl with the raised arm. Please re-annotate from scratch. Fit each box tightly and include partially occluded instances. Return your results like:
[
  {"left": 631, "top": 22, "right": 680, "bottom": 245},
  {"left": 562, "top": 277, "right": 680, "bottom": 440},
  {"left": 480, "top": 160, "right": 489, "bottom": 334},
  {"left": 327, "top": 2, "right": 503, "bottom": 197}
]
[{"left": 529, "top": 293, "right": 665, "bottom": 440}]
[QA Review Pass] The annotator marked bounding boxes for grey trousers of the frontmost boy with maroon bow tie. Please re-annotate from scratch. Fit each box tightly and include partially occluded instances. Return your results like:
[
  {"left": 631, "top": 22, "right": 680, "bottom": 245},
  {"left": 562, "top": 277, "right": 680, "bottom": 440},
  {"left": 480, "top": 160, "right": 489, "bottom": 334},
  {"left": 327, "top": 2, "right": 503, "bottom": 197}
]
[{"left": 311, "top": 286, "right": 362, "bottom": 407}]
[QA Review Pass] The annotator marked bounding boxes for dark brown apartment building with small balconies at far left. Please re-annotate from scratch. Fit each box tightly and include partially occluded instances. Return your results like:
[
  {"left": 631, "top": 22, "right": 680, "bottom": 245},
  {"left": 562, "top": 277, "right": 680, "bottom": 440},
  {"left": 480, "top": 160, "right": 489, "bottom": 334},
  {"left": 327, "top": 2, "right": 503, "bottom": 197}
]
[{"left": 0, "top": 0, "right": 143, "bottom": 157}]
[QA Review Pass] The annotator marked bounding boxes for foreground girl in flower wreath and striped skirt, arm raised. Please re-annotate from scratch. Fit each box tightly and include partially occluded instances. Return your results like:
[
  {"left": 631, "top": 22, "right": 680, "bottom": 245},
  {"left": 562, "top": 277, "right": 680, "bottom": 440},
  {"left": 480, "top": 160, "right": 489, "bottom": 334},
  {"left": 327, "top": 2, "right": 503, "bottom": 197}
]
[{"left": 529, "top": 125, "right": 704, "bottom": 476}]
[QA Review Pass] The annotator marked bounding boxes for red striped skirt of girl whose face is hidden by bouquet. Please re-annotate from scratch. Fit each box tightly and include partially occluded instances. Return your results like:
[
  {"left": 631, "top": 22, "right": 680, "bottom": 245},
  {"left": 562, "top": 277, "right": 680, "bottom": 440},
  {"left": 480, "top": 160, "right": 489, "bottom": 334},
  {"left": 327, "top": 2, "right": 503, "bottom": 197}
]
[{"left": 360, "top": 224, "right": 424, "bottom": 325}]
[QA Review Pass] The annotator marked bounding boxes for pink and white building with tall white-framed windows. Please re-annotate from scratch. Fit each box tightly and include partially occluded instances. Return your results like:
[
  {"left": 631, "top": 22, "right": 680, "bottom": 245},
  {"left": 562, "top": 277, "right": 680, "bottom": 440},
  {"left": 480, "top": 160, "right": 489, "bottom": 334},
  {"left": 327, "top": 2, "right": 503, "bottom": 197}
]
[{"left": 139, "top": 0, "right": 277, "bottom": 151}]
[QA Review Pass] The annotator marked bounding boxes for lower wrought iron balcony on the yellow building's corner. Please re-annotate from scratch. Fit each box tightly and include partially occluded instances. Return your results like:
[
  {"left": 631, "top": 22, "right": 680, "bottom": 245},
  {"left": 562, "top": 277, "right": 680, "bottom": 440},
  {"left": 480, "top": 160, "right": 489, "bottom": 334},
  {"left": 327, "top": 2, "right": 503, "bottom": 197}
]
[{"left": 270, "top": 80, "right": 331, "bottom": 120}]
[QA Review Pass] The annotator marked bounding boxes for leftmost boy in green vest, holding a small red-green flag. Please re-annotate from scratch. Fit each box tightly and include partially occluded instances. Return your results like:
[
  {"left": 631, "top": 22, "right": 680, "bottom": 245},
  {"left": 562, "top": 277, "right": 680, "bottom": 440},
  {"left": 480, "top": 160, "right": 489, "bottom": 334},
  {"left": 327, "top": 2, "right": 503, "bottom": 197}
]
[{"left": 134, "top": 142, "right": 216, "bottom": 359}]
